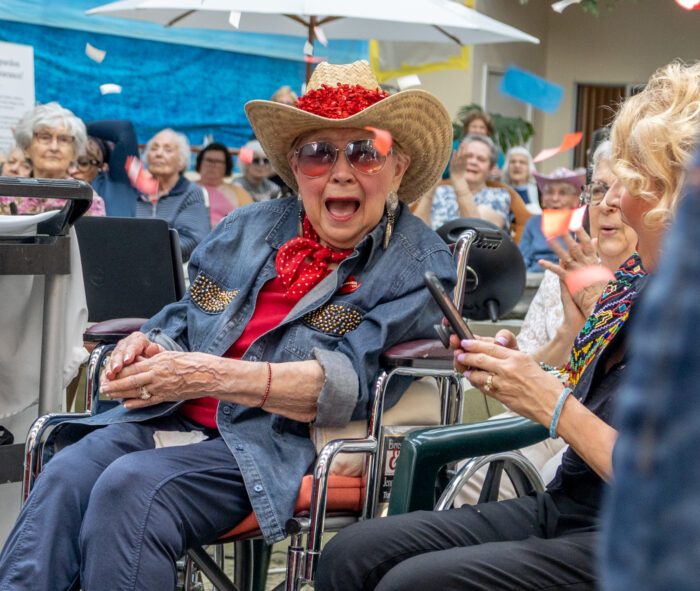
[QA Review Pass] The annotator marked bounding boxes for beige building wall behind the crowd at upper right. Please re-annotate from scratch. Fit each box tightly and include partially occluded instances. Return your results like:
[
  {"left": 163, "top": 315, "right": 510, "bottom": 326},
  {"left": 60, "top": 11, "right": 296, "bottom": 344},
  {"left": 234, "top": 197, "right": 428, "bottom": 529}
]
[{"left": 421, "top": 0, "right": 700, "bottom": 173}]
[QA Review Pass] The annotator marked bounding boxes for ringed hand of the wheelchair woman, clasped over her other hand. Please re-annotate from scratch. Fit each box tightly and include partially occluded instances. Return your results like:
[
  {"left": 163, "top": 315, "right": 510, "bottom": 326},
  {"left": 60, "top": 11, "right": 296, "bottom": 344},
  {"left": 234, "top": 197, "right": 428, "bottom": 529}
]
[{"left": 101, "top": 351, "right": 231, "bottom": 408}]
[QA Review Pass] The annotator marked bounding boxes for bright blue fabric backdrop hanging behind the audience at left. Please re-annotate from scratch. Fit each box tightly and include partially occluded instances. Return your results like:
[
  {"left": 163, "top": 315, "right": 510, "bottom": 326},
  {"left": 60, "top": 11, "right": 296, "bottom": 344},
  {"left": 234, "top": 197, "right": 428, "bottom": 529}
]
[{"left": 0, "top": 6, "right": 366, "bottom": 146}]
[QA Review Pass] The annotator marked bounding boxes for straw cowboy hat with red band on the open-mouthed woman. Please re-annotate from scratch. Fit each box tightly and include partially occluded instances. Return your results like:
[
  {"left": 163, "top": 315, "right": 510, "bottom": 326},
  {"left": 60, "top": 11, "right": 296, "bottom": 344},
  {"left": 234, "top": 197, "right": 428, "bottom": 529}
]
[{"left": 245, "top": 60, "right": 452, "bottom": 203}]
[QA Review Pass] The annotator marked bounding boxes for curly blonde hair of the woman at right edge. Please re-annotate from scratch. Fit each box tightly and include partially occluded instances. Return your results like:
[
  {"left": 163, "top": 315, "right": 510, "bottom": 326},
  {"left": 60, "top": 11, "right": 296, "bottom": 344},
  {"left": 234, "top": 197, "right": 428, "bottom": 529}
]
[{"left": 610, "top": 61, "right": 700, "bottom": 227}]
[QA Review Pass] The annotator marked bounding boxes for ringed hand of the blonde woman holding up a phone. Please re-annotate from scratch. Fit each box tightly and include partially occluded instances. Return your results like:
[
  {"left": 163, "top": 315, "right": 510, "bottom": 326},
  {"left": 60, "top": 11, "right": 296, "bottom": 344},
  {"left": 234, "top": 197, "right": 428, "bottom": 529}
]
[{"left": 451, "top": 338, "right": 562, "bottom": 425}]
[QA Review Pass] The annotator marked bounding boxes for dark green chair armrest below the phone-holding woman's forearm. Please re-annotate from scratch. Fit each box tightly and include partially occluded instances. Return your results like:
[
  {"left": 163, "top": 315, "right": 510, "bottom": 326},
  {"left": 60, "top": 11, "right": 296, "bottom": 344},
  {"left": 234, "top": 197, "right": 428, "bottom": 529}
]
[{"left": 389, "top": 417, "right": 549, "bottom": 515}]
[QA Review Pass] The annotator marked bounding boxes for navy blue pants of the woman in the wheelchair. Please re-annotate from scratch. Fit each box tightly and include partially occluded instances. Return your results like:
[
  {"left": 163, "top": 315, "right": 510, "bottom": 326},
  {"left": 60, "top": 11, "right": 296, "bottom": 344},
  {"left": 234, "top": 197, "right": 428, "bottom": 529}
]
[{"left": 0, "top": 415, "right": 252, "bottom": 591}]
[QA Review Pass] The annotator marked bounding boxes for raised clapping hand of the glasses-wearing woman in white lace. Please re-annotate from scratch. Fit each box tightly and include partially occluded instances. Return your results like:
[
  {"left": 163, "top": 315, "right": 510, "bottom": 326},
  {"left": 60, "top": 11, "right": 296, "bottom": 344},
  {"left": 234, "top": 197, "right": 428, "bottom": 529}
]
[{"left": 537, "top": 228, "right": 606, "bottom": 325}]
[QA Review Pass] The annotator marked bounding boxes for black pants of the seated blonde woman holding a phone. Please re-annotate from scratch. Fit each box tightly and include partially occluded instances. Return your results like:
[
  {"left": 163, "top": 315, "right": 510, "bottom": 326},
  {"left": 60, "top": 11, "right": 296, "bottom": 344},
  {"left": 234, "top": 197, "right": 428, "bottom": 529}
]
[{"left": 316, "top": 493, "right": 598, "bottom": 591}]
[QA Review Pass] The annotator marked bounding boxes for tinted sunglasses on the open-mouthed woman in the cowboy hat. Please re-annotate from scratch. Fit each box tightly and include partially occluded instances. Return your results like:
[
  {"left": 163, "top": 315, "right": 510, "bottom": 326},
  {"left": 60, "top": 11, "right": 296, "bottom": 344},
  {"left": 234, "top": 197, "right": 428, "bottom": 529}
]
[{"left": 294, "top": 139, "right": 386, "bottom": 179}]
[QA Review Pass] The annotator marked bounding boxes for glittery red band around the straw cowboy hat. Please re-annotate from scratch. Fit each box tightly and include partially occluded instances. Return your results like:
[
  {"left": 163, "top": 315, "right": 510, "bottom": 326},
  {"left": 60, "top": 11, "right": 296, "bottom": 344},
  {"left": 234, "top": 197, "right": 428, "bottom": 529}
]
[{"left": 297, "top": 82, "right": 389, "bottom": 119}]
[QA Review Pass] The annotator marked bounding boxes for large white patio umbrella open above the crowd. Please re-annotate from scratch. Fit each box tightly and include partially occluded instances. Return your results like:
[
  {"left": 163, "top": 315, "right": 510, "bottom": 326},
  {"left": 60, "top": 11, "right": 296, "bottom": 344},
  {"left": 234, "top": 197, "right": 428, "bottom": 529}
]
[{"left": 86, "top": 0, "right": 539, "bottom": 80}]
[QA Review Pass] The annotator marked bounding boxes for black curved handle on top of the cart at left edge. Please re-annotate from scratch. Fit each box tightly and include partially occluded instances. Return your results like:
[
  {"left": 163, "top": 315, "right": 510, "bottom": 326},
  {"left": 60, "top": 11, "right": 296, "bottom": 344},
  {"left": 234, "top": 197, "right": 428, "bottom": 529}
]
[{"left": 0, "top": 177, "right": 93, "bottom": 236}]
